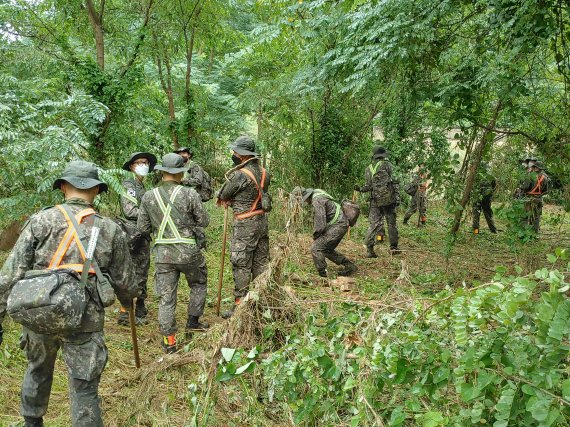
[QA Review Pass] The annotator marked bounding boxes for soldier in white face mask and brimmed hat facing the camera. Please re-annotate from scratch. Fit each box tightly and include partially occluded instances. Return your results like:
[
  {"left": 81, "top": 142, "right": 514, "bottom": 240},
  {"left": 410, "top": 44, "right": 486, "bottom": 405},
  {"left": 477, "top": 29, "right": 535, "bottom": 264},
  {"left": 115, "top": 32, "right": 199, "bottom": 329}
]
[{"left": 118, "top": 152, "right": 156, "bottom": 326}]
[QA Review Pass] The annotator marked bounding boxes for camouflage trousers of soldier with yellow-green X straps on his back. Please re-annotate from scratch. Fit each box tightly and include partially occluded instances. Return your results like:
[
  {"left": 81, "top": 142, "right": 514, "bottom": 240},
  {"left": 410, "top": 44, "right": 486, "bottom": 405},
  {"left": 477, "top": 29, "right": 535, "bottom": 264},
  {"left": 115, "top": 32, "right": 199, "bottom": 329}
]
[{"left": 155, "top": 252, "right": 208, "bottom": 336}]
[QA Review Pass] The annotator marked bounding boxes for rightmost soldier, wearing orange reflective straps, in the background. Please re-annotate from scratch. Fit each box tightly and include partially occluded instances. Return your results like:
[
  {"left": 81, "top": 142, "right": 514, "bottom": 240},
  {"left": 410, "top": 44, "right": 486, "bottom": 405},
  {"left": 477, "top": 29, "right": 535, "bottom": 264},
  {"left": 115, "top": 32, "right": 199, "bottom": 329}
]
[{"left": 515, "top": 159, "right": 550, "bottom": 233}]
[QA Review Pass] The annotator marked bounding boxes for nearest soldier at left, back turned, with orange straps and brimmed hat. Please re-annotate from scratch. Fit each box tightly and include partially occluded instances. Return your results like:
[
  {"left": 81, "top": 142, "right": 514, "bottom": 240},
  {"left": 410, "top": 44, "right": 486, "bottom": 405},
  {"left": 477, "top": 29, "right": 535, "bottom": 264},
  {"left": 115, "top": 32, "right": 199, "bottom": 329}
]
[{"left": 0, "top": 161, "right": 139, "bottom": 427}]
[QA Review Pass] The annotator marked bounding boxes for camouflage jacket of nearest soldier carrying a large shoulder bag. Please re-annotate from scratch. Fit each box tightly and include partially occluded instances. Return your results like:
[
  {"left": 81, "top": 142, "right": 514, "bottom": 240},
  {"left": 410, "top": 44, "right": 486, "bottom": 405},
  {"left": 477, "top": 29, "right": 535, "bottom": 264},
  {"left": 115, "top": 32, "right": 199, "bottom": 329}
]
[{"left": 0, "top": 199, "right": 140, "bottom": 332}]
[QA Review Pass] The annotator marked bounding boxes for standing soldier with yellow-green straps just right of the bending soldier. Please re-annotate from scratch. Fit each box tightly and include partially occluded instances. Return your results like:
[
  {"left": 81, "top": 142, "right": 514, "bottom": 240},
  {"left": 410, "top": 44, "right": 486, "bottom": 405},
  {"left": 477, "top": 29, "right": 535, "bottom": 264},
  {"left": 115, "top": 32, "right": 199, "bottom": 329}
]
[{"left": 354, "top": 146, "right": 400, "bottom": 258}]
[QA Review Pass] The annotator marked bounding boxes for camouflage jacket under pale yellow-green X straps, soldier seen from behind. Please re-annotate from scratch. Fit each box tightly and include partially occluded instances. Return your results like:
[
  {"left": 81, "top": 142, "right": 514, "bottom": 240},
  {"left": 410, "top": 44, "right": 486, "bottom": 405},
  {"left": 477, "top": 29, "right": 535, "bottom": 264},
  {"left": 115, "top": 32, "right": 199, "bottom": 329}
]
[{"left": 137, "top": 181, "right": 210, "bottom": 264}]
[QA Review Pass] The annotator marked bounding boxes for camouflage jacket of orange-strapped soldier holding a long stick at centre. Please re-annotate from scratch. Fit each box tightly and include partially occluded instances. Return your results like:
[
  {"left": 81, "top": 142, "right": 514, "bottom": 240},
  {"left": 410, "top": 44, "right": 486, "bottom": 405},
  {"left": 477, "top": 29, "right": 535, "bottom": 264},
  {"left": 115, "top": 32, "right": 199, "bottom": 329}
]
[{"left": 218, "top": 160, "right": 271, "bottom": 214}]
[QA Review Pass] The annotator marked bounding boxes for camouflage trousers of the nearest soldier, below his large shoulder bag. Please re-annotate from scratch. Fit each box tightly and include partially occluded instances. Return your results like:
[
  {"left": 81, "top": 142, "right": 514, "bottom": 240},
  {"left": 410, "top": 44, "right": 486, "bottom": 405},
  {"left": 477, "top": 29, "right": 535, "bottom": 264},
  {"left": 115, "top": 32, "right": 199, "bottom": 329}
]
[{"left": 20, "top": 328, "right": 107, "bottom": 427}]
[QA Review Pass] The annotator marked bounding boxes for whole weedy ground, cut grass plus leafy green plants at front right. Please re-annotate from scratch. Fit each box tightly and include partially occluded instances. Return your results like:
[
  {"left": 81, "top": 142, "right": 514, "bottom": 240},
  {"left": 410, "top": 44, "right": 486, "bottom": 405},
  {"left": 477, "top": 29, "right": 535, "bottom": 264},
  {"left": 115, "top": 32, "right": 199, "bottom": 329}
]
[{"left": 0, "top": 202, "right": 570, "bottom": 427}]
